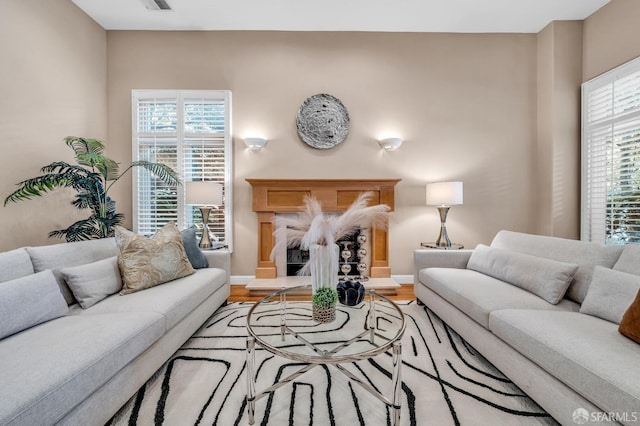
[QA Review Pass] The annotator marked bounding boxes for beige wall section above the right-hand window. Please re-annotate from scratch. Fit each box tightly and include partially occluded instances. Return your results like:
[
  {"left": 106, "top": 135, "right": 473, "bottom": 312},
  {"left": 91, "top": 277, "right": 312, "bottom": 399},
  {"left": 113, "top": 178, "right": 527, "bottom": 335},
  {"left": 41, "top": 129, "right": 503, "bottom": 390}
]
[{"left": 582, "top": 0, "right": 640, "bottom": 81}]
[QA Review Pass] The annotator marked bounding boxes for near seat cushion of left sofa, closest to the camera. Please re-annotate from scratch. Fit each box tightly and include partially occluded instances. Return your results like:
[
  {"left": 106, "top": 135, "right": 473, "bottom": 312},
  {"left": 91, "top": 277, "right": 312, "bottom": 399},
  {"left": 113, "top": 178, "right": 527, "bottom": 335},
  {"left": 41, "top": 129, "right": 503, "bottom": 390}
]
[{"left": 0, "top": 312, "right": 164, "bottom": 425}]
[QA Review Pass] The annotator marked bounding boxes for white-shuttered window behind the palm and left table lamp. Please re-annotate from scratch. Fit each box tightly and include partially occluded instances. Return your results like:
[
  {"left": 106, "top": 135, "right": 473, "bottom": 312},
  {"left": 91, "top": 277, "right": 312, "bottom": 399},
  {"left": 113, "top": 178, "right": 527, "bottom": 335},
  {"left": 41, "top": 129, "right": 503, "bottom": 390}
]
[{"left": 132, "top": 90, "right": 233, "bottom": 250}]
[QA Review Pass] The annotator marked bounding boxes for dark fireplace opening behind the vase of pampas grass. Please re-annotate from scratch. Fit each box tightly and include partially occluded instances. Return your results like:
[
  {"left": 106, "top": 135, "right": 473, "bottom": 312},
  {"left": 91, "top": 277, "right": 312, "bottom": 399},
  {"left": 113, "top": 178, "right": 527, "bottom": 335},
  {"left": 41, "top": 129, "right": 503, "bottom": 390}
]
[{"left": 286, "top": 228, "right": 368, "bottom": 281}]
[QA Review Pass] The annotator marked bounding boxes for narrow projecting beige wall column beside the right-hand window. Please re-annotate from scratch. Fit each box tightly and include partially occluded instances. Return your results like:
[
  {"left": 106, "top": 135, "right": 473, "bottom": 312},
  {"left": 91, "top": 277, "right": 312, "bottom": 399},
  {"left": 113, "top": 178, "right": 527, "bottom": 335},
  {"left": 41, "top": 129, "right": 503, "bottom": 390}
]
[{"left": 536, "top": 21, "right": 582, "bottom": 239}]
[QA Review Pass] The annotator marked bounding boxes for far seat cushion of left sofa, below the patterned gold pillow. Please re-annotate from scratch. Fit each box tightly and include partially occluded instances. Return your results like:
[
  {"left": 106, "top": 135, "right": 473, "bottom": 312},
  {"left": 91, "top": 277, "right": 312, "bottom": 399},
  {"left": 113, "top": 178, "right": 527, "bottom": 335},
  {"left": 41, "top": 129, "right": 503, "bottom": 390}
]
[{"left": 71, "top": 268, "right": 227, "bottom": 330}]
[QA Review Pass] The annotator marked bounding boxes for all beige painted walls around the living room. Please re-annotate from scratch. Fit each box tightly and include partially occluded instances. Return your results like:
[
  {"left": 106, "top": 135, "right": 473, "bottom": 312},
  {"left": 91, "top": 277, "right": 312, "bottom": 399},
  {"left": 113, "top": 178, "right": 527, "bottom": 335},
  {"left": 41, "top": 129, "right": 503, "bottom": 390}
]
[{"left": 7, "top": 0, "right": 628, "bottom": 275}]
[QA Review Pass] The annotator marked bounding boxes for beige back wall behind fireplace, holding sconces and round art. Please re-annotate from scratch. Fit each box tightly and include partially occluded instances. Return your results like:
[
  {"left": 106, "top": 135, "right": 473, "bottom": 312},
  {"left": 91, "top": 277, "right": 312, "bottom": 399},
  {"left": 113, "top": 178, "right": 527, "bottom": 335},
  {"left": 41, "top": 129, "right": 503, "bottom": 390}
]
[{"left": 107, "top": 31, "right": 537, "bottom": 275}]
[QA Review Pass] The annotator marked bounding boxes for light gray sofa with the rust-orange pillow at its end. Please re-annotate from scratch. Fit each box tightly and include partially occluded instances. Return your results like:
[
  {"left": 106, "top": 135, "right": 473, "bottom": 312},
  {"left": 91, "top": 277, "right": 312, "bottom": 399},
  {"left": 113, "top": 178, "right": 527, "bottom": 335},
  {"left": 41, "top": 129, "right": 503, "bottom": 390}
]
[{"left": 414, "top": 231, "right": 640, "bottom": 425}]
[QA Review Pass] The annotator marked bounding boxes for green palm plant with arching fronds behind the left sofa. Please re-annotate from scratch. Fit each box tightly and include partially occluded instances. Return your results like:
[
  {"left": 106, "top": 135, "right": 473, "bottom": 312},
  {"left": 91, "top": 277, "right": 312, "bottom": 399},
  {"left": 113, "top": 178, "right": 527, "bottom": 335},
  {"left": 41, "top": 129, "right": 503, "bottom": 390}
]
[{"left": 4, "top": 136, "right": 180, "bottom": 241}]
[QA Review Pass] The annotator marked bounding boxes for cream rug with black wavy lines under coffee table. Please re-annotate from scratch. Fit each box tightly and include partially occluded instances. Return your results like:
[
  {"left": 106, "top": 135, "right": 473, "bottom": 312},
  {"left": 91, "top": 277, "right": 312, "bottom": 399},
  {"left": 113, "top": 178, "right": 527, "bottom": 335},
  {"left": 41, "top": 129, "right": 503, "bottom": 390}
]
[{"left": 109, "top": 301, "right": 557, "bottom": 426}]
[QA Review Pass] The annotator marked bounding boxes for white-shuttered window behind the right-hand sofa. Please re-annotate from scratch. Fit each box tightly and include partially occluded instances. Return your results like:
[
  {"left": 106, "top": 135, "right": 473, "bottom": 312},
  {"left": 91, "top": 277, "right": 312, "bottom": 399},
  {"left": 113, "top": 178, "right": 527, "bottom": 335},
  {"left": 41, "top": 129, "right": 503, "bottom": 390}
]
[{"left": 581, "top": 58, "right": 640, "bottom": 244}]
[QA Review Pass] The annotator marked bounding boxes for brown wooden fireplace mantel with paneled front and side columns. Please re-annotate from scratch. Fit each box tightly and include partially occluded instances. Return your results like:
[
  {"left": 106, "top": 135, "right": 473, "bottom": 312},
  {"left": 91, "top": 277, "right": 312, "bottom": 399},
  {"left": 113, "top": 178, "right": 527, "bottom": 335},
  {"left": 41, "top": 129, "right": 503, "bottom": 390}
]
[{"left": 246, "top": 179, "right": 400, "bottom": 278}]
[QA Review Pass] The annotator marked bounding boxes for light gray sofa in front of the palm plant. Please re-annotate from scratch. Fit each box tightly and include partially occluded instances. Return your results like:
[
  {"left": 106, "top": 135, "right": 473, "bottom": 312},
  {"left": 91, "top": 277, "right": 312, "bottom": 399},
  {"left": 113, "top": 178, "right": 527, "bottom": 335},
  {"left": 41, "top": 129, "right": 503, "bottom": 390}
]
[{"left": 0, "top": 238, "right": 230, "bottom": 426}]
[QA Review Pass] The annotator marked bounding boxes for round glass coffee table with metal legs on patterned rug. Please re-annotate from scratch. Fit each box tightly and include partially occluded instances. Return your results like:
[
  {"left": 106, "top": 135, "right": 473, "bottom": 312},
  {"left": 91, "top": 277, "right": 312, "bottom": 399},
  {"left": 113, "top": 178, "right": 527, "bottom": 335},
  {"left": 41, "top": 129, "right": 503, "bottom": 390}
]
[{"left": 246, "top": 286, "right": 405, "bottom": 425}]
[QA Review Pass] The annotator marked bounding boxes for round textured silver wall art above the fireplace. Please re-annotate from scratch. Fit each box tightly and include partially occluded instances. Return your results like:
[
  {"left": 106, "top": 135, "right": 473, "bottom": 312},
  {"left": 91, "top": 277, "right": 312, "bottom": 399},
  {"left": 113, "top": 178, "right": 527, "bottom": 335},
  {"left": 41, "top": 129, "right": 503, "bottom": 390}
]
[{"left": 296, "top": 93, "right": 349, "bottom": 149}]
